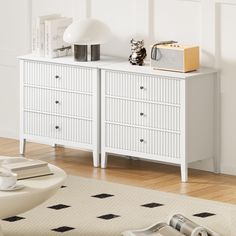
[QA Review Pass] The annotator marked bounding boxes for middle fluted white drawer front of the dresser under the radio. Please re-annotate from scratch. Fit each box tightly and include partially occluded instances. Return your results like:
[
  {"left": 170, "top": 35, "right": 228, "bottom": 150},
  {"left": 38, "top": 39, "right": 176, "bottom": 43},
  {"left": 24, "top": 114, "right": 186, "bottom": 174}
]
[{"left": 105, "top": 97, "right": 180, "bottom": 131}]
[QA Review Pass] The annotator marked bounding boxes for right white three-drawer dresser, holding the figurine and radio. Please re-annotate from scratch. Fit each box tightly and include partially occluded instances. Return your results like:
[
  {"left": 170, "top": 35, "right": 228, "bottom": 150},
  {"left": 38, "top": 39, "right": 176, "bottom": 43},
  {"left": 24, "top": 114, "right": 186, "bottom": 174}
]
[{"left": 101, "top": 62, "right": 218, "bottom": 182}]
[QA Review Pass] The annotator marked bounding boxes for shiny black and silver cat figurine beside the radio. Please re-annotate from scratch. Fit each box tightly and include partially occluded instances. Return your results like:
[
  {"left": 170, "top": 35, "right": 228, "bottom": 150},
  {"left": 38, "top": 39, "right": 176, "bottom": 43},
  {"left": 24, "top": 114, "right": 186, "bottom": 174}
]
[{"left": 129, "top": 39, "right": 147, "bottom": 66}]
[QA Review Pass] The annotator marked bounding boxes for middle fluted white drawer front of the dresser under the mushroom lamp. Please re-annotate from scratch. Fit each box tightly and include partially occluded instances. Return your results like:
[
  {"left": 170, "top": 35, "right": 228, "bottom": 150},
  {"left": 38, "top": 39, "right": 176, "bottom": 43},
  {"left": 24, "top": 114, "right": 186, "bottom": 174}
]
[{"left": 24, "top": 86, "right": 92, "bottom": 119}]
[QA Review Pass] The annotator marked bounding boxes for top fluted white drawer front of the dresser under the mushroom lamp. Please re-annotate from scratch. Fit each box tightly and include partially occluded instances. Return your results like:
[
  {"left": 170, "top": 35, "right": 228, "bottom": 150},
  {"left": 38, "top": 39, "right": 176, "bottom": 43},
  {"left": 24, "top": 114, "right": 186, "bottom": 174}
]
[{"left": 24, "top": 61, "right": 93, "bottom": 93}]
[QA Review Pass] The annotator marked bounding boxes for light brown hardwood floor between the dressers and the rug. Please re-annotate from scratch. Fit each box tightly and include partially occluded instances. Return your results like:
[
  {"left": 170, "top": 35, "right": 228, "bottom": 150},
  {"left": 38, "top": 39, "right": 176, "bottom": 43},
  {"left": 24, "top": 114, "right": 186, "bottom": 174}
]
[{"left": 0, "top": 138, "right": 236, "bottom": 204}]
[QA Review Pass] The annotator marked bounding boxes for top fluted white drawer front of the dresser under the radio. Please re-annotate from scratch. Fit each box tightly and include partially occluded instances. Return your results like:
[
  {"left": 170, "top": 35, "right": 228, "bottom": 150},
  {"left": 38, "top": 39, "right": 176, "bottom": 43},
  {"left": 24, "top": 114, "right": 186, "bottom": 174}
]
[{"left": 105, "top": 70, "right": 180, "bottom": 104}]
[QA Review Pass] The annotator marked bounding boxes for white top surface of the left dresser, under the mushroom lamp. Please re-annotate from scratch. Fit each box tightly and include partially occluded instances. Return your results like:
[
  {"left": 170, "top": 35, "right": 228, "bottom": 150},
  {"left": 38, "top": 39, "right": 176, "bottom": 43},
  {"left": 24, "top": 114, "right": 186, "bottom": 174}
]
[{"left": 18, "top": 54, "right": 124, "bottom": 68}]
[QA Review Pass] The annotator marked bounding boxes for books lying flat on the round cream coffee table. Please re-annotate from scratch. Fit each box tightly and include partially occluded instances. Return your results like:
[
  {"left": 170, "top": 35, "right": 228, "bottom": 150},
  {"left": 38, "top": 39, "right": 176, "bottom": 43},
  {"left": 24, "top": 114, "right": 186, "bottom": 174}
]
[{"left": 1, "top": 158, "right": 52, "bottom": 180}]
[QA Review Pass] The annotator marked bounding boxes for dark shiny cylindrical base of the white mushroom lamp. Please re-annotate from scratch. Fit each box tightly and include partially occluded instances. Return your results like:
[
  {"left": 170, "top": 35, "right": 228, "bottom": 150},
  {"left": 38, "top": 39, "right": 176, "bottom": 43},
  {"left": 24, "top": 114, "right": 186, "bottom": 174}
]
[{"left": 74, "top": 44, "right": 100, "bottom": 61}]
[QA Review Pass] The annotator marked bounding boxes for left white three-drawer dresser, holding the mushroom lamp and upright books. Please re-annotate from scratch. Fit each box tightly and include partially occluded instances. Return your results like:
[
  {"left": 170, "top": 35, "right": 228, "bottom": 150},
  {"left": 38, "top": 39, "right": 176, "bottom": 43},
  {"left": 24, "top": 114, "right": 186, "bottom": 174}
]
[{"left": 19, "top": 55, "right": 114, "bottom": 167}]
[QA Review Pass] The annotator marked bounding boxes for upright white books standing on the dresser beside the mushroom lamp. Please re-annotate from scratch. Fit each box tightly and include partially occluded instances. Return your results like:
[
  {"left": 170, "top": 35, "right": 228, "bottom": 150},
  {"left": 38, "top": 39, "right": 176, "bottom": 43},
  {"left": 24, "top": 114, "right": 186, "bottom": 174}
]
[{"left": 32, "top": 14, "right": 72, "bottom": 58}]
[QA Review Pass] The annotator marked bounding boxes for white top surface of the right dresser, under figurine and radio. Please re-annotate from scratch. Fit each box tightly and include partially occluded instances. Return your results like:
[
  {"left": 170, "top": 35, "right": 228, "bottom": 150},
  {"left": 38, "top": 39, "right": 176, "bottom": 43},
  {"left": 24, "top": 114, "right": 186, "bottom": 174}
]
[{"left": 100, "top": 61, "right": 217, "bottom": 79}]
